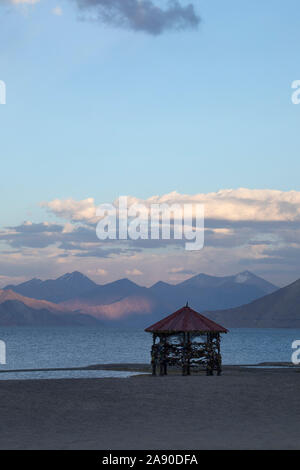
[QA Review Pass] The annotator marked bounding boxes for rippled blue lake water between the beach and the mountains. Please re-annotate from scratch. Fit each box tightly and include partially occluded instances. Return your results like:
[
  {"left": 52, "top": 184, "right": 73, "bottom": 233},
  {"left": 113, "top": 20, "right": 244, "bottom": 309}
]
[{"left": 0, "top": 327, "right": 300, "bottom": 379}]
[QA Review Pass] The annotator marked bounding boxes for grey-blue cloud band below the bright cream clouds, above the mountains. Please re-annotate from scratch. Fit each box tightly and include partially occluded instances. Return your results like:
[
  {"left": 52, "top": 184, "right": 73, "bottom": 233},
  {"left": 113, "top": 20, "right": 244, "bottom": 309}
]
[{"left": 0, "top": 219, "right": 300, "bottom": 277}]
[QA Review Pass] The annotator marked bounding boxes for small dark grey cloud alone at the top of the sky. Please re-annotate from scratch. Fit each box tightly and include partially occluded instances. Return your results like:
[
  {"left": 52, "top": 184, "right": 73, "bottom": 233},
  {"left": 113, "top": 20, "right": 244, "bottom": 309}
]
[{"left": 75, "top": 0, "right": 200, "bottom": 35}]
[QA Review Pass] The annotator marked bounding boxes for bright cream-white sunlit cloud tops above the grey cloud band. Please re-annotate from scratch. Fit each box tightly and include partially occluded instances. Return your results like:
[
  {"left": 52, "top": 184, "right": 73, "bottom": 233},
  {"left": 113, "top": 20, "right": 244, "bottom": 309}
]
[{"left": 42, "top": 188, "right": 300, "bottom": 223}]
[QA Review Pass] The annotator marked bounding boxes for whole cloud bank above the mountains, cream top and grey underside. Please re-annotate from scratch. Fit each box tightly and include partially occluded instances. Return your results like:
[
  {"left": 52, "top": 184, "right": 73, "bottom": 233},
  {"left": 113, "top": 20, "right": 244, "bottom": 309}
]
[{"left": 0, "top": 188, "right": 300, "bottom": 285}]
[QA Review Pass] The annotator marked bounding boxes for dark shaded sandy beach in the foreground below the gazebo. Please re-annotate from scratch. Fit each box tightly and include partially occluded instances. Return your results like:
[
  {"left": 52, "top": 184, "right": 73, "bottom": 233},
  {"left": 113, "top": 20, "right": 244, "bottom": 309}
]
[{"left": 0, "top": 366, "right": 300, "bottom": 450}]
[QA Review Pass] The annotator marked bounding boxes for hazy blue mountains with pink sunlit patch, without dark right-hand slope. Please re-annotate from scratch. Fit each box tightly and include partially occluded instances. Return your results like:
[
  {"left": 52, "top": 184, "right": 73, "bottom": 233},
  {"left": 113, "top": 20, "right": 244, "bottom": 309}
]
[{"left": 0, "top": 271, "right": 284, "bottom": 327}]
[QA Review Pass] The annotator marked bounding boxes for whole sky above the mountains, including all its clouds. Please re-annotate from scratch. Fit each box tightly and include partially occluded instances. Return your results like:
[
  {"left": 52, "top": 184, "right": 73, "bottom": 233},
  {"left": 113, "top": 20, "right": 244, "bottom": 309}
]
[{"left": 0, "top": 0, "right": 300, "bottom": 287}]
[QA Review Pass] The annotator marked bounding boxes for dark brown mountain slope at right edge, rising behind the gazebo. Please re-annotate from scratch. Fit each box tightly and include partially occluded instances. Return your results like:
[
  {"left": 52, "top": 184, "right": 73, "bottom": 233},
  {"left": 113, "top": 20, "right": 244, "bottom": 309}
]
[{"left": 205, "top": 279, "right": 300, "bottom": 328}]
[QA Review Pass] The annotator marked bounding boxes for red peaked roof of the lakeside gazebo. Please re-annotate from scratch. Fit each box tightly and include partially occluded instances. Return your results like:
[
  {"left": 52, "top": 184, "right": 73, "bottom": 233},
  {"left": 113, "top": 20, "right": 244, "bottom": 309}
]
[{"left": 145, "top": 305, "right": 228, "bottom": 333}]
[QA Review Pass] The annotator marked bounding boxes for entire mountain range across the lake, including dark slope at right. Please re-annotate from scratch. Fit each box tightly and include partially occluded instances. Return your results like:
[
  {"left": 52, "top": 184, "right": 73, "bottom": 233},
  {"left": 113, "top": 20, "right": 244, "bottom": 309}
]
[{"left": 0, "top": 271, "right": 300, "bottom": 328}]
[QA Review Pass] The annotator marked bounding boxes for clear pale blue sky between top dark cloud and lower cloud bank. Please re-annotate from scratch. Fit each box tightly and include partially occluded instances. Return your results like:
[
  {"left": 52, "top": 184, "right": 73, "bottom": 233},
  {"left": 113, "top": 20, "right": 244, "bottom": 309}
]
[{"left": 0, "top": 0, "right": 300, "bottom": 282}]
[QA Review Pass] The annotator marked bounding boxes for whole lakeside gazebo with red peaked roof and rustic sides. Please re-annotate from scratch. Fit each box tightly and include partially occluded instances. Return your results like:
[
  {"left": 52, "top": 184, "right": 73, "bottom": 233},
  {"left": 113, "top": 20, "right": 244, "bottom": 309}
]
[{"left": 145, "top": 303, "right": 228, "bottom": 375}]
